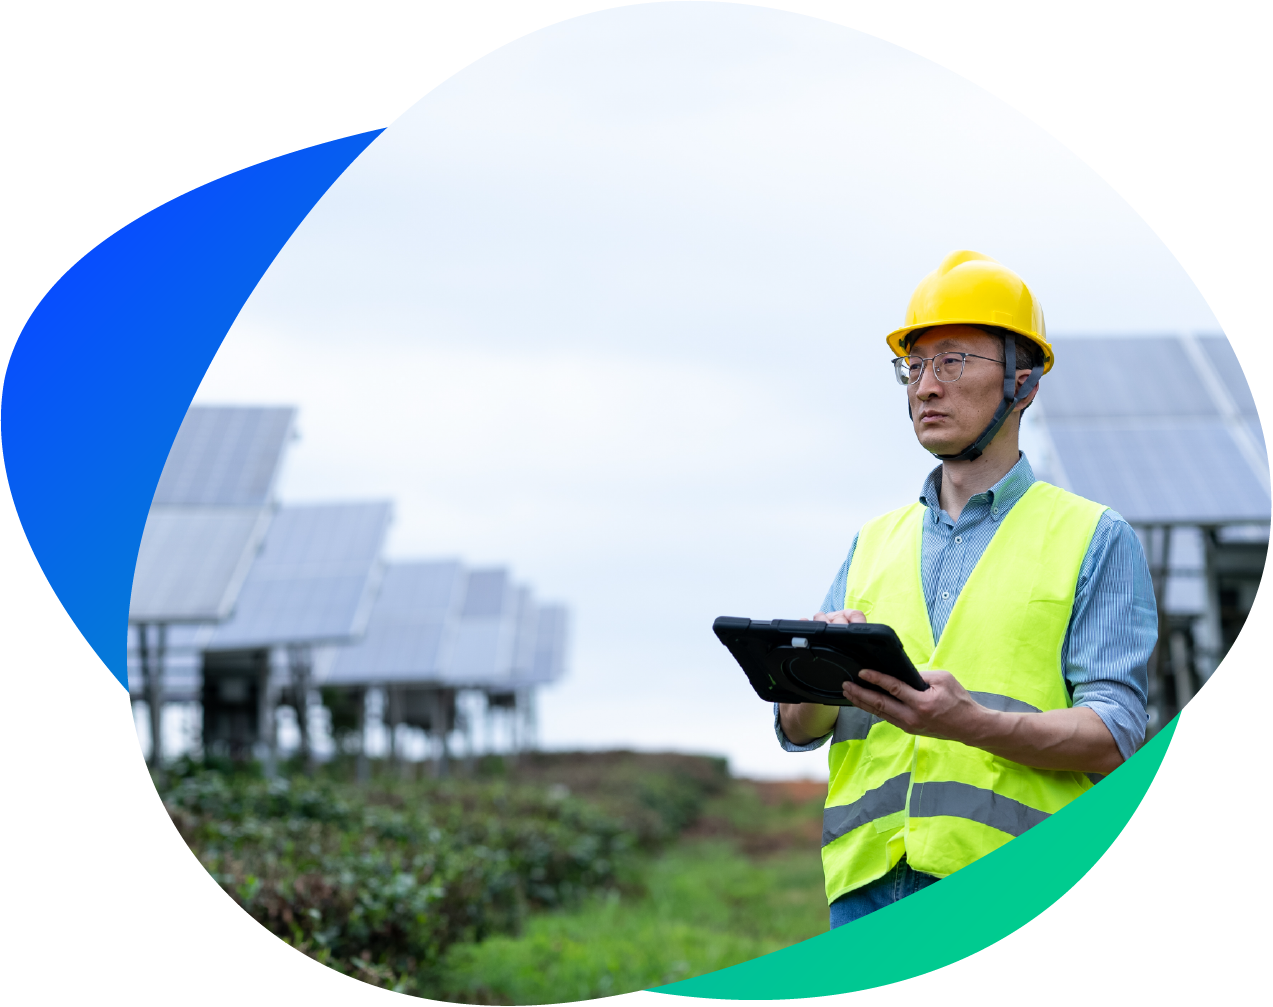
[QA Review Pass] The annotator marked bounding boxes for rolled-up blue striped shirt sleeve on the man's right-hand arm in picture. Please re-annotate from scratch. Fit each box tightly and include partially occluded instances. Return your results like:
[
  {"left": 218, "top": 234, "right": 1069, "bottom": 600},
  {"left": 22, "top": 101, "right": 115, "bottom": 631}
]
[{"left": 1062, "top": 511, "right": 1158, "bottom": 760}]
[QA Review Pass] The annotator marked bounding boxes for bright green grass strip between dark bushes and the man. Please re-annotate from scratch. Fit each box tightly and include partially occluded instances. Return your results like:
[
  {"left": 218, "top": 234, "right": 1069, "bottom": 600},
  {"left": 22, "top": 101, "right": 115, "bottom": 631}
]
[{"left": 432, "top": 784, "right": 827, "bottom": 1004}]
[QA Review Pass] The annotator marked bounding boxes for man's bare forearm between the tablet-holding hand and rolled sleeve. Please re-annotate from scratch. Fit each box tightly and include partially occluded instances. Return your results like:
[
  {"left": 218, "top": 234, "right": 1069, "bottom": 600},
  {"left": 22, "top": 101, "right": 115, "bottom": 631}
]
[{"left": 965, "top": 707, "right": 1123, "bottom": 774}]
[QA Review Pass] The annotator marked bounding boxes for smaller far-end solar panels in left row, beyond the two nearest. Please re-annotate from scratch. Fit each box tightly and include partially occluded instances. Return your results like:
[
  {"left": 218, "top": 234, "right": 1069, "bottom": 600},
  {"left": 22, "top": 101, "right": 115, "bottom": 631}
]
[{"left": 325, "top": 560, "right": 566, "bottom": 690}]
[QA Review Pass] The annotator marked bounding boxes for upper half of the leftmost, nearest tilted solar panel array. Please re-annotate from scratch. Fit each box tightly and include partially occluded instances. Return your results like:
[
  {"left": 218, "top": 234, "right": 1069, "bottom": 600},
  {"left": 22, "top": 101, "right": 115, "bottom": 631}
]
[{"left": 153, "top": 406, "right": 295, "bottom": 507}]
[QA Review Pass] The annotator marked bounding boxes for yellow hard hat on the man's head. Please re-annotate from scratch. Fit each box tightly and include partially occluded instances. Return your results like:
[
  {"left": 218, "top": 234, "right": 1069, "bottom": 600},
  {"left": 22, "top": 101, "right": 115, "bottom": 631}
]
[{"left": 887, "top": 250, "right": 1053, "bottom": 374}]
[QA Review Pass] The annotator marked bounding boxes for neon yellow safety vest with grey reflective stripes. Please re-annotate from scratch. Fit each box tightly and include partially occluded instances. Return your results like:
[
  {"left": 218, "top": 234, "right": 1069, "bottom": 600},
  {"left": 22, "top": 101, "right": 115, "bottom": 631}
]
[{"left": 822, "top": 482, "right": 1105, "bottom": 901}]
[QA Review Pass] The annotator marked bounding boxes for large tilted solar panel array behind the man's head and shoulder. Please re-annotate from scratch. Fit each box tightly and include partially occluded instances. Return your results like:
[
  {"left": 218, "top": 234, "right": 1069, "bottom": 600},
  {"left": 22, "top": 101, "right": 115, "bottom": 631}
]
[{"left": 1036, "top": 336, "right": 1273, "bottom": 525}]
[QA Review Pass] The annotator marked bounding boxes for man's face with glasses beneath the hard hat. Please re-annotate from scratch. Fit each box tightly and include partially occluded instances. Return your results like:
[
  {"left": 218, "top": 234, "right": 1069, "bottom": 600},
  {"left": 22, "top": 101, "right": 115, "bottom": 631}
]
[{"left": 906, "top": 325, "right": 1013, "bottom": 454}]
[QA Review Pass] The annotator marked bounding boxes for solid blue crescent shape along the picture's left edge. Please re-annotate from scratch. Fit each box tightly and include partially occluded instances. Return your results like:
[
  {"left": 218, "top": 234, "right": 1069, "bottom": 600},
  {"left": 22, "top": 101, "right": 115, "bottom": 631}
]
[{"left": 0, "top": 130, "right": 382, "bottom": 689}]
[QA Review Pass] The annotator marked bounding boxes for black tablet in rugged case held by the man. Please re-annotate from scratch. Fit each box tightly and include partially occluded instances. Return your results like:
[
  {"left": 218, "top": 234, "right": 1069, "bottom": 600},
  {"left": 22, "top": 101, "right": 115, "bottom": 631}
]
[{"left": 712, "top": 615, "right": 928, "bottom": 707}]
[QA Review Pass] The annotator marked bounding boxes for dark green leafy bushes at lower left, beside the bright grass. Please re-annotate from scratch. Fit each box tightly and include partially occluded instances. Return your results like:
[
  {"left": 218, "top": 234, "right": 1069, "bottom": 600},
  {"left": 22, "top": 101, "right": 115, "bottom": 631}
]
[{"left": 162, "top": 764, "right": 634, "bottom": 992}]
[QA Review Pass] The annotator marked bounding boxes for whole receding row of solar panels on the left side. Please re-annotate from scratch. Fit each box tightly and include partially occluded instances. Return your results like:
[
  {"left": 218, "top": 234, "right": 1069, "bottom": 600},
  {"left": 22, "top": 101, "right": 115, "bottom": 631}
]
[{"left": 129, "top": 406, "right": 566, "bottom": 699}]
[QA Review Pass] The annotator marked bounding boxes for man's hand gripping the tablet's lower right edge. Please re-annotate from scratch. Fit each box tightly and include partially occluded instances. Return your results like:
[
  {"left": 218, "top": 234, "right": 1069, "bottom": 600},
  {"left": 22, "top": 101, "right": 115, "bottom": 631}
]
[{"left": 844, "top": 668, "right": 990, "bottom": 743}]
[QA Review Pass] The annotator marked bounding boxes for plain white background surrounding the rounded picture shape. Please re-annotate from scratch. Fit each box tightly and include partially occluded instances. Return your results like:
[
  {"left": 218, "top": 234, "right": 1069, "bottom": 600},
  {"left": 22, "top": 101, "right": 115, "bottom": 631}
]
[{"left": 0, "top": 3, "right": 1273, "bottom": 1002}]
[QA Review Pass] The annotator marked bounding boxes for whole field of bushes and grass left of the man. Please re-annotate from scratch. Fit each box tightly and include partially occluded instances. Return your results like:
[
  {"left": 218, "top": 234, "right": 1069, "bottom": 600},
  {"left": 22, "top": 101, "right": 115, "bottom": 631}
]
[{"left": 160, "top": 752, "right": 827, "bottom": 1004}]
